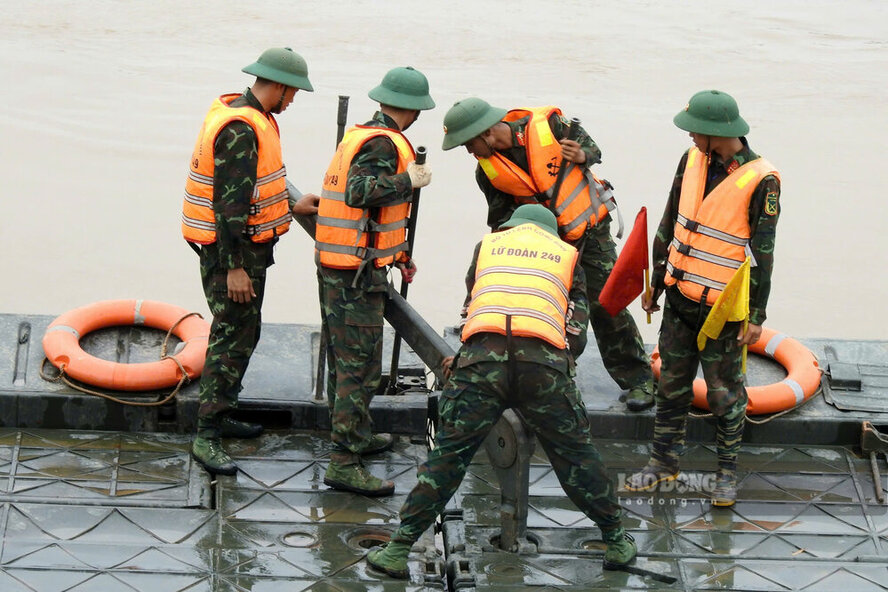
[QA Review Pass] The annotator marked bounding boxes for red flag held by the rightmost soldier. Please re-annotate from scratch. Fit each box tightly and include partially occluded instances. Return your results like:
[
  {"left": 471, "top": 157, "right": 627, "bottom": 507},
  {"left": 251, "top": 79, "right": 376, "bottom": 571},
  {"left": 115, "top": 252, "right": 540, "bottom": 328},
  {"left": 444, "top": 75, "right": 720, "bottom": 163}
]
[{"left": 598, "top": 208, "right": 649, "bottom": 316}]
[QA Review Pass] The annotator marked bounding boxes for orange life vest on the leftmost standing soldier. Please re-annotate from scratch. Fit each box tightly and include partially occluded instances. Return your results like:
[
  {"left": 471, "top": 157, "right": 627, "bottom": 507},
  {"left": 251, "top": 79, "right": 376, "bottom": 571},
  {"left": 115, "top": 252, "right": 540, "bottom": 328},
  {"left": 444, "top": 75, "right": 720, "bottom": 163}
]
[{"left": 182, "top": 94, "right": 292, "bottom": 245}]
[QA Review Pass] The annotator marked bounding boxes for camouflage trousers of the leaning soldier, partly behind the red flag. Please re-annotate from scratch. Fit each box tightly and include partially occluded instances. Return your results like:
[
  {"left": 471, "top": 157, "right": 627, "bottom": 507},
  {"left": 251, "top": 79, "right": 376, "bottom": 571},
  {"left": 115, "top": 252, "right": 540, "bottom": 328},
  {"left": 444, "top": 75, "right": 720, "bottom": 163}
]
[{"left": 580, "top": 220, "right": 653, "bottom": 390}]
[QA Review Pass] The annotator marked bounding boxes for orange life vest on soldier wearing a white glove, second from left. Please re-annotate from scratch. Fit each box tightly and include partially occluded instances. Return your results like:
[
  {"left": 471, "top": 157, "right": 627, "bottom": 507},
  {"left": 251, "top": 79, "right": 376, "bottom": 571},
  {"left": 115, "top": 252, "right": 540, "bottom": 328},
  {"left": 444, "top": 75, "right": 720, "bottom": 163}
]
[{"left": 315, "top": 125, "right": 416, "bottom": 269}]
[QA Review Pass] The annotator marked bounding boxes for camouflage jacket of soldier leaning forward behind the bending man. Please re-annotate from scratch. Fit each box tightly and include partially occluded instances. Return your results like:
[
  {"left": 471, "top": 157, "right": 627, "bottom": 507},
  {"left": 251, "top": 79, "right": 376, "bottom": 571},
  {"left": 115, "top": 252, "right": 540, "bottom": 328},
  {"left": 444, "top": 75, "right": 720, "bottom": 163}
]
[{"left": 475, "top": 114, "right": 601, "bottom": 230}]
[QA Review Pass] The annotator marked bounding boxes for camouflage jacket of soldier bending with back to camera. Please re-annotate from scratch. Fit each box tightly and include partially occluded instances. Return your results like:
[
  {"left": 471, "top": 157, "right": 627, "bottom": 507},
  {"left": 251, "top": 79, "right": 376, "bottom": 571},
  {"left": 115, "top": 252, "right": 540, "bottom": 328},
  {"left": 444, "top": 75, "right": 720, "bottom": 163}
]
[{"left": 457, "top": 242, "right": 589, "bottom": 375}]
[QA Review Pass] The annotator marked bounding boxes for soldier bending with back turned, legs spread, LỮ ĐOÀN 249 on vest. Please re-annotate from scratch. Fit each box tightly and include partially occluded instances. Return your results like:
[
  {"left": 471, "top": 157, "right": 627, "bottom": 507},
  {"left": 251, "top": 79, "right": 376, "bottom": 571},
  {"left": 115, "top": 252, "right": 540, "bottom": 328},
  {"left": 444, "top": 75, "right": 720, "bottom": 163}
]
[{"left": 367, "top": 204, "right": 637, "bottom": 578}]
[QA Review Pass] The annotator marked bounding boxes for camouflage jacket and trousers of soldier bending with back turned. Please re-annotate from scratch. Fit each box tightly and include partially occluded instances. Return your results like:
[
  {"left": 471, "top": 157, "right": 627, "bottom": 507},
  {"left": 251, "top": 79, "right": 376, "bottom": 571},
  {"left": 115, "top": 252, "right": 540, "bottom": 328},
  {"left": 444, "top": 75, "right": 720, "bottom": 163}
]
[{"left": 392, "top": 244, "right": 622, "bottom": 543}]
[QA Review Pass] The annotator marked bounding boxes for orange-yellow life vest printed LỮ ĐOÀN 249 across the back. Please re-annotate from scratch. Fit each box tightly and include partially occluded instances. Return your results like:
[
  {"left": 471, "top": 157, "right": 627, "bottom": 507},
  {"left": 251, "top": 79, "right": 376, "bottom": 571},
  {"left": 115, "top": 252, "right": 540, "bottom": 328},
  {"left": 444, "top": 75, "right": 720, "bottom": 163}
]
[{"left": 462, "top": 223, "right": 577, "bottom": 349}]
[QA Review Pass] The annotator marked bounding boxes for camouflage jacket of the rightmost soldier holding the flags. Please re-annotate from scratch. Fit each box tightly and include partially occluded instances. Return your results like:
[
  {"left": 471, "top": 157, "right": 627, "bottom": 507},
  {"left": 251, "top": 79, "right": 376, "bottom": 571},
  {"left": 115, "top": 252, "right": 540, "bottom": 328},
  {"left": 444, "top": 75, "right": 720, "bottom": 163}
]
[{"left": 651, "top": 138, "right": 780, "bottom": 325}]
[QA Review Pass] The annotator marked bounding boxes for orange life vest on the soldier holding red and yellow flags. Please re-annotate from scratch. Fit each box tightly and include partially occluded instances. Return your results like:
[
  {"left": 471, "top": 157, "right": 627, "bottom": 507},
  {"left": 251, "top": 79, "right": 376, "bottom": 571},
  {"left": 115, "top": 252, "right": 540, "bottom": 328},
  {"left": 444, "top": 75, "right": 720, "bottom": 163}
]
[{"left": 665, "top": 148, "right": 780, "bottom": 306}]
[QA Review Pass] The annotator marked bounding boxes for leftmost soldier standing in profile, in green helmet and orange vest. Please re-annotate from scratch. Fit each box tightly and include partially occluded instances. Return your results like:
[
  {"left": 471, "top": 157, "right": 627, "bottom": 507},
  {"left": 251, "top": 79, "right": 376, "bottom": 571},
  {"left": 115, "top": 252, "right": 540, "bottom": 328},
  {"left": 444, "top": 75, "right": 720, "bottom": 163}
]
[{"left": 182, "top": 47, "right": 320, "bottom": 475}]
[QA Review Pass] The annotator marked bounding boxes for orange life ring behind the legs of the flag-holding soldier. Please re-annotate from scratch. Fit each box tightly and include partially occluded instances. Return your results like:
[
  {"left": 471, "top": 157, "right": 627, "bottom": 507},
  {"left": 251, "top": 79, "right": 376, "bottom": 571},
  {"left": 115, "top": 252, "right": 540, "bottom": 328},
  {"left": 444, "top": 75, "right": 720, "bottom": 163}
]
[{"left": 651, "top": 327, "right": 821, "bottom": 415}]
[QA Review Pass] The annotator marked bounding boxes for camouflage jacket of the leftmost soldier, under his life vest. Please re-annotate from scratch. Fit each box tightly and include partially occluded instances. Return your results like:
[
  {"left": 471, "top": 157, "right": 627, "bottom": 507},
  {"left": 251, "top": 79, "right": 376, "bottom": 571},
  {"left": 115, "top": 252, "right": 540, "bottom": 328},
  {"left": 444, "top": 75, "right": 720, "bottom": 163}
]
[{"left": 208, "top": 88, "right": 277, "bottom": 277}]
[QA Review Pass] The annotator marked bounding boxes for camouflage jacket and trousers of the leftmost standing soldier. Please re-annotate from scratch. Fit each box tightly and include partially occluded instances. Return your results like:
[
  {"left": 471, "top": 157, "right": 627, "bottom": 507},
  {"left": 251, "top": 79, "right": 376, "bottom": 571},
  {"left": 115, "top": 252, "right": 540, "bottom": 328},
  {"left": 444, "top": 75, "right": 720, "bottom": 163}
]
[{"left": 197, "top": 89, "right": 277, "bottom": 438}]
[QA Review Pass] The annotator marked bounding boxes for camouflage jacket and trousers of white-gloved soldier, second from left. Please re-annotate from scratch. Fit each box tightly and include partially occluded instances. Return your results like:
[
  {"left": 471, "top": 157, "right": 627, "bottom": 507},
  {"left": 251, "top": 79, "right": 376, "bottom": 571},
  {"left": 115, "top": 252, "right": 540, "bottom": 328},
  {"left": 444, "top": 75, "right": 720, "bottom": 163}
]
[{"left": 318, "top": 112, "right": 413, "bottom": 462}]
